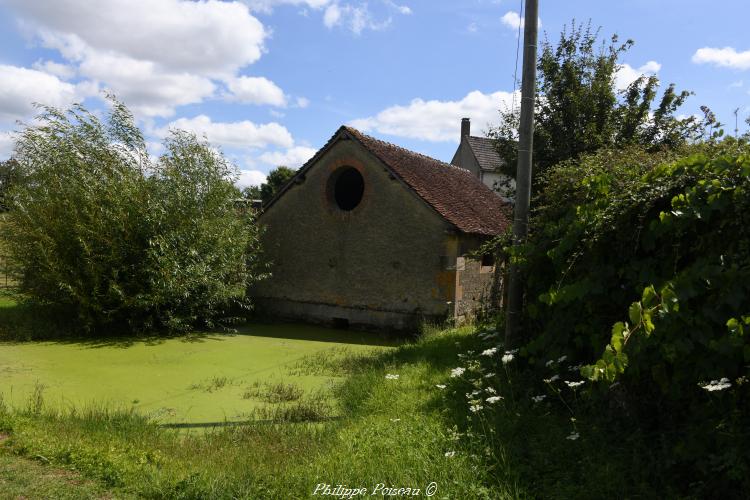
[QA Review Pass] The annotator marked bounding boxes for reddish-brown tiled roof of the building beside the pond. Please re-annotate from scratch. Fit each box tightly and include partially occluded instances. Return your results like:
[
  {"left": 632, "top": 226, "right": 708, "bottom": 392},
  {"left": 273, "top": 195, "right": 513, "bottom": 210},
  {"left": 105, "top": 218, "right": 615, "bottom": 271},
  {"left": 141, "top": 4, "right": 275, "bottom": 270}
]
[{"left": 265, "top": 126, "right": 510, "bottom": 236}]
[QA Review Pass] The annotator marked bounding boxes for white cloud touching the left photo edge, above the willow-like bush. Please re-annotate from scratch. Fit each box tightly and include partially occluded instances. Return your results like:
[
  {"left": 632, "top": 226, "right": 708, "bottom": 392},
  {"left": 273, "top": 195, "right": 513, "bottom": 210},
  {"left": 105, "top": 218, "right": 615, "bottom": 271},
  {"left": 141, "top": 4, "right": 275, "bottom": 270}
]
[{"left": 0, "top": 64, "right": 82, "bottom": 120}]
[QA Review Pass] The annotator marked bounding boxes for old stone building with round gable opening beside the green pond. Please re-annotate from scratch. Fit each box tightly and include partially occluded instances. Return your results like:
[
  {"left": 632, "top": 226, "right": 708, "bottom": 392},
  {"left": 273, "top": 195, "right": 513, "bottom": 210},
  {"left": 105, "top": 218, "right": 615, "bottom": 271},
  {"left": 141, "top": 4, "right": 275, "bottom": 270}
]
[{"left": 253, "top": 127, "right": 510, "bottom": 330}]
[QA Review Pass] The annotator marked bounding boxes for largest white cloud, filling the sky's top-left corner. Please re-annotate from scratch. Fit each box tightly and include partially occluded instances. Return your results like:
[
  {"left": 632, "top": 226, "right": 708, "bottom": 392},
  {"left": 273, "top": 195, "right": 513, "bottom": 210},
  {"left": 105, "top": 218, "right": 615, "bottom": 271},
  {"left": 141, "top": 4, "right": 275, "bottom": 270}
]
[{"left": 6, "top": 0, "right": 274, "bottom": 116}]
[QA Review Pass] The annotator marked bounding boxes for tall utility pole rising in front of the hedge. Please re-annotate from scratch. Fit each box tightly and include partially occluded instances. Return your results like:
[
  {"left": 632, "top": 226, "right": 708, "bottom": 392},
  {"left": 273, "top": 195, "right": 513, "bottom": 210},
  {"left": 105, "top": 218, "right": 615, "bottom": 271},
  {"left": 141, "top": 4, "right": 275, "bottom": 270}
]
[{"left": 505, "top": 0, "right": 539, "bottom": 349}]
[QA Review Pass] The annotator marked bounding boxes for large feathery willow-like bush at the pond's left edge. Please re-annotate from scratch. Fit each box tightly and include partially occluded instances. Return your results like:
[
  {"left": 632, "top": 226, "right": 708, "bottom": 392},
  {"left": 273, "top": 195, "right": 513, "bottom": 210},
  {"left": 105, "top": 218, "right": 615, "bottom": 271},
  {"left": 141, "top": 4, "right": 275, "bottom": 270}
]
[{"left": 2, "top": 99, "right": 260, "bottom": 332}]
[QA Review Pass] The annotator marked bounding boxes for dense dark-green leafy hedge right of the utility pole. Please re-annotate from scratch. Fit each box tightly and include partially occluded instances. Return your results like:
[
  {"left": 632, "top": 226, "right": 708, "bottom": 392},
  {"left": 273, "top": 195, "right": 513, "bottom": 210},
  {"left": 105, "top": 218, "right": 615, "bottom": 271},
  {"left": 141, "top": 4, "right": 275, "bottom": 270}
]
[{"left": 522, "top": 140, "right": 750, "bottom": 495}]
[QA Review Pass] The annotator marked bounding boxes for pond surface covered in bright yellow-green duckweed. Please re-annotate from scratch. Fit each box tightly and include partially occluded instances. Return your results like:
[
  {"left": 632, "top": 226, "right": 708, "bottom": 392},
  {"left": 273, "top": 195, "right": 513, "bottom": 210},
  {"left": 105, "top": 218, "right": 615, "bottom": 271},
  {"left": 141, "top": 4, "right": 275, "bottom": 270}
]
[{"left": 0, "top": 324, "right": 394, "bottom": 424}]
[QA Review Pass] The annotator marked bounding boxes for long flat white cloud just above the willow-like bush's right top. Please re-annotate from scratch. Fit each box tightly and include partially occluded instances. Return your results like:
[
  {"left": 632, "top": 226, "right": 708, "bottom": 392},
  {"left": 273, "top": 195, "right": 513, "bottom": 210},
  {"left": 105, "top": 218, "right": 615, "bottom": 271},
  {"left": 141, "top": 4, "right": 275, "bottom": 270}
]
[{"left": 155, "top": 115, "right": 294, "bottom": 149}]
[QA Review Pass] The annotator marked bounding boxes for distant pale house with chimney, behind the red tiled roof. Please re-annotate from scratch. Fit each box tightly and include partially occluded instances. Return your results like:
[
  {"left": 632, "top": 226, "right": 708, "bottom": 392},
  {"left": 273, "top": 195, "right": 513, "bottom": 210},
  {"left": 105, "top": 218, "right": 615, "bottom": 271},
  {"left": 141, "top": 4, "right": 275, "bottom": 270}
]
[{"left": 451, "top": 118, "right": 516, "bottom": 202}]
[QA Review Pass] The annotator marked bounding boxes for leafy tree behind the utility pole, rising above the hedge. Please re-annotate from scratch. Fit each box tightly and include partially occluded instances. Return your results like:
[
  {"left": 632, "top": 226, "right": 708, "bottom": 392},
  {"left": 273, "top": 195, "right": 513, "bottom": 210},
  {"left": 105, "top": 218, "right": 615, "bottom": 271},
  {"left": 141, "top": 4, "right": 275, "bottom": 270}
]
[{"left": 490, "top": 22, "right": 720, "bottom": 183}]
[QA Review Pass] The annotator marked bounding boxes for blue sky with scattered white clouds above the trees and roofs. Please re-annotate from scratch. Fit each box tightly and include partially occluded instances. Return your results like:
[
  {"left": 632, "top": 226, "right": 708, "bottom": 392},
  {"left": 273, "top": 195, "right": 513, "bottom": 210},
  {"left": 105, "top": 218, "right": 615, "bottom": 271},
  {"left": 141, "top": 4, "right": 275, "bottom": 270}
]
[{"left": 0, "top": 0, "right": 750, "bottom": 185}]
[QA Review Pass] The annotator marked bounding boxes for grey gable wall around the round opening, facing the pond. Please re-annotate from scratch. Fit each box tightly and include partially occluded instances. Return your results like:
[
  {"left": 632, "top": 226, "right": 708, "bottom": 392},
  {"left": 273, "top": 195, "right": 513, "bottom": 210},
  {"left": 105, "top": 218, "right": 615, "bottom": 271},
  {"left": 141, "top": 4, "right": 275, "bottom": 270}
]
[{"left": 251, "top": 141, "right": 459, "bottom": 328}]
